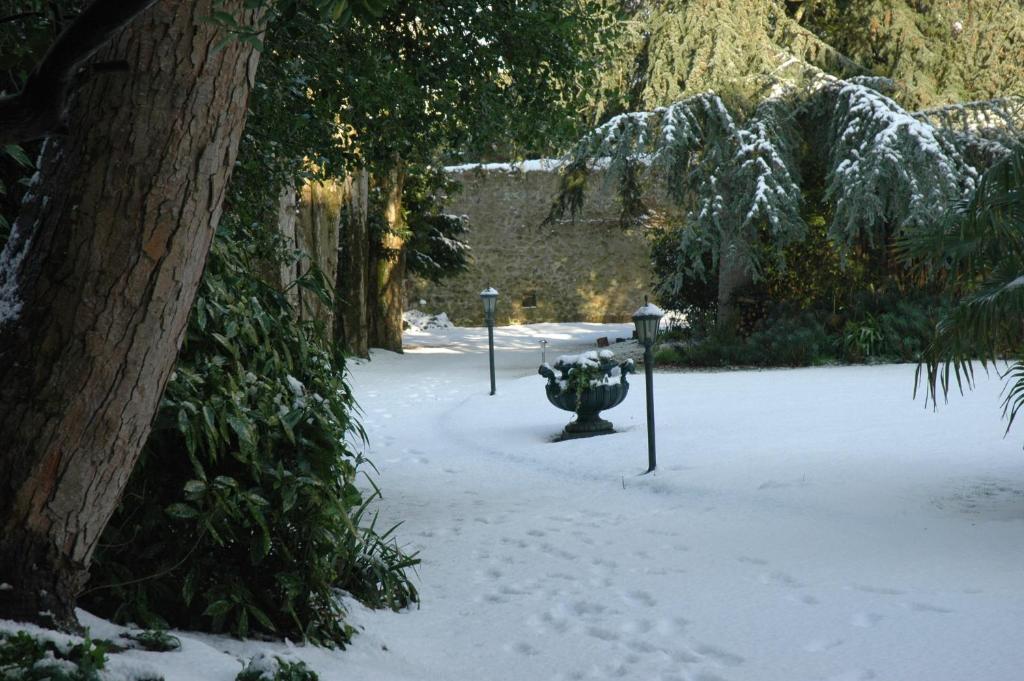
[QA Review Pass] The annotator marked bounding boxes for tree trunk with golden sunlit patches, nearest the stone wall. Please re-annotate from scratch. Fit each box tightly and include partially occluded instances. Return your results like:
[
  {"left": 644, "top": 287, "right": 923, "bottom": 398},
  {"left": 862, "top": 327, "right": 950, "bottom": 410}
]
[{"left": 370, "top": 163, "right": 406, "bottom": 352}]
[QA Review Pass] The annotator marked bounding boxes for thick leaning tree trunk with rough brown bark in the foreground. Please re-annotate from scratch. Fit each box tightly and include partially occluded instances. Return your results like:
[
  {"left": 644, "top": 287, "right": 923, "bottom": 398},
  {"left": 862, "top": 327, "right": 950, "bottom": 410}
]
[{"left": 0, "top": 0, "right": 258, "bottom": 628}]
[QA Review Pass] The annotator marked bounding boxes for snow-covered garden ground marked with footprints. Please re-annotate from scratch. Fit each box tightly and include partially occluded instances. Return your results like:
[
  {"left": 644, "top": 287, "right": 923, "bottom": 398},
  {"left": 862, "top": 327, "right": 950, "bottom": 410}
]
[{"left": 2, "top": 324, "right": 1024, "bottom": 681}]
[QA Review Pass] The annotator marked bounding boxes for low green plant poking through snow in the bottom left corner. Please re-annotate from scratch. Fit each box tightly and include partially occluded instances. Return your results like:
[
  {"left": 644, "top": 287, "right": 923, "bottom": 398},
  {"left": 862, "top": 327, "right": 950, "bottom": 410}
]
[{"left": 0, "top": 631, "right": 119, "bottom": 681}]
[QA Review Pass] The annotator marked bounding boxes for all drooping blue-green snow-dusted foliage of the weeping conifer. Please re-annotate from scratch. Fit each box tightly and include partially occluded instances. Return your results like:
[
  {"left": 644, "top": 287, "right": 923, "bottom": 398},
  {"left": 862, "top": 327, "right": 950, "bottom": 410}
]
[{"left": 553, "top": 70, "right": 977, "bottom": 323}]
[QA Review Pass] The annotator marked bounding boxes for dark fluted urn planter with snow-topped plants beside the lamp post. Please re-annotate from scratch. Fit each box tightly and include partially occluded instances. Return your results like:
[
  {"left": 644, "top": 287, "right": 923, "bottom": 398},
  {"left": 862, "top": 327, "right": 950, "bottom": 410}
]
[{"left": 538, "top": 350, "right": 634, "bottom": 439}]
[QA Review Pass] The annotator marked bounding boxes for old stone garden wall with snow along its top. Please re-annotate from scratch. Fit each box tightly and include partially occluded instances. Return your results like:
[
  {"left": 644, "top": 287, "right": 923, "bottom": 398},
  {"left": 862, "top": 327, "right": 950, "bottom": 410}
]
[{"left": 407, "top": 163, "right": 653, "bottom": 326}]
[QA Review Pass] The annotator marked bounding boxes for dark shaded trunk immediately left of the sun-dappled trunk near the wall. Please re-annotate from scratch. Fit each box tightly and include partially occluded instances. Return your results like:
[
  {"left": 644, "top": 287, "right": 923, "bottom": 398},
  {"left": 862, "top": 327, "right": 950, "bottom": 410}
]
[{"left": 335, "top": 169, "right": 370, "bottom": 357}]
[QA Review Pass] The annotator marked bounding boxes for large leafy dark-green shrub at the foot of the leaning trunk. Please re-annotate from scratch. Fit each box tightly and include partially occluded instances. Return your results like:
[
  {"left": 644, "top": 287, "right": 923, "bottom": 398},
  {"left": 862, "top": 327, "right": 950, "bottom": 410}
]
[{"left": 84, "top": 227, "right": 418, "bottom": 645}]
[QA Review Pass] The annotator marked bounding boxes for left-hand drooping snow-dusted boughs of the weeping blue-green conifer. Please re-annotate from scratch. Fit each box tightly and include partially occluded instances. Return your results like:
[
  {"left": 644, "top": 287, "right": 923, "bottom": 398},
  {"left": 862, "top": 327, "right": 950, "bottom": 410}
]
[{"left": 556, "top": 92, "right": 806, "bottom": 284}]
